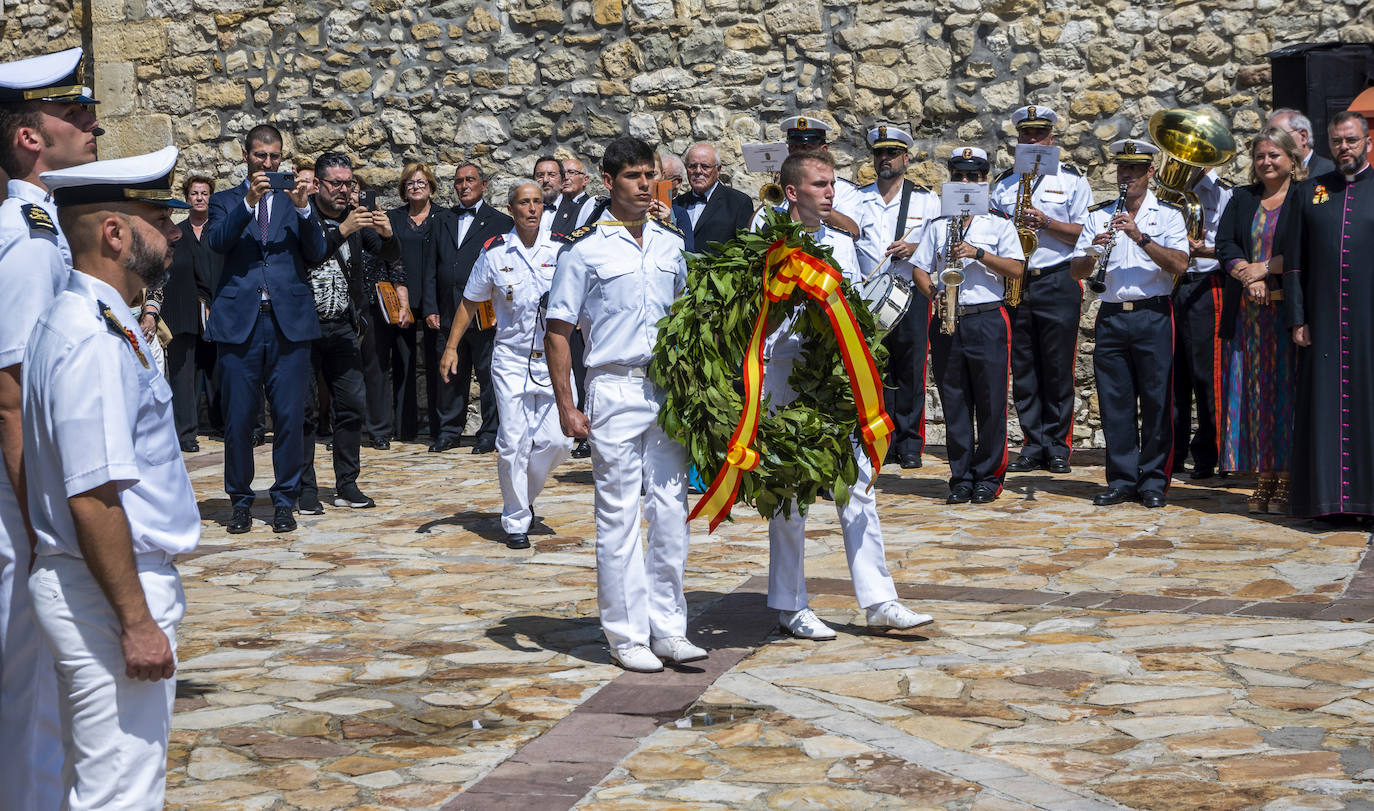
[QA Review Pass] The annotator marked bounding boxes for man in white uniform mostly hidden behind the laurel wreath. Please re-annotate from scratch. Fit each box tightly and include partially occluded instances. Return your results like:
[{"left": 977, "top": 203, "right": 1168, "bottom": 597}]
[{"left": 764, "top": 151, "right": 933, "bottom": 639}]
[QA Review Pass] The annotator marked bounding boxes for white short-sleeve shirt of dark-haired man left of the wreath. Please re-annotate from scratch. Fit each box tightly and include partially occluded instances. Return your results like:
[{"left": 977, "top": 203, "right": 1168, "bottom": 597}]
[{"left": 545, "top": 219, "right": 687, "bottom": 368}]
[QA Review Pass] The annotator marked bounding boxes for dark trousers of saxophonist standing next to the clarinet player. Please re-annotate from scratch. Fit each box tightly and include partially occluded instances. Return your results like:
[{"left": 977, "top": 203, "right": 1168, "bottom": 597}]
[{"left": 1010, "top": 263, "right": 1083, "bottom": 465}]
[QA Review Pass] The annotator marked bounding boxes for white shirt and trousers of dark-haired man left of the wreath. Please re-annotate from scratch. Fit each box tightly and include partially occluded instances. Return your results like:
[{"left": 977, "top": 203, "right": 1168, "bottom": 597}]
[{"left": 547, "top": 220, "right": 688, "bottom": 649}]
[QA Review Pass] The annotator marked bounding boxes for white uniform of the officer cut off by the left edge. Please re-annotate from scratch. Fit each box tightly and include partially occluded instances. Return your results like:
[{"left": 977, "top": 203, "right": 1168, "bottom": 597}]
[{"left": 0, "top": 180, "right": 68, "bottom": 811}]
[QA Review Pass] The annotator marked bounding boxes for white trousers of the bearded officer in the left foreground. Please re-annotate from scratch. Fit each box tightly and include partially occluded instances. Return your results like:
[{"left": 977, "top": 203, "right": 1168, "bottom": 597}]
[{"left": 29, "top": 555, "right": 185, "bottom": 811}]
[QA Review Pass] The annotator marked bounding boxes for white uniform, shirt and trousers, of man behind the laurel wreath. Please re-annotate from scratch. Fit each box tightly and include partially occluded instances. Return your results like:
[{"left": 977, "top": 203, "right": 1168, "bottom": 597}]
[{"left": 764, "top": 225, "right": 897, "bottom": 612}]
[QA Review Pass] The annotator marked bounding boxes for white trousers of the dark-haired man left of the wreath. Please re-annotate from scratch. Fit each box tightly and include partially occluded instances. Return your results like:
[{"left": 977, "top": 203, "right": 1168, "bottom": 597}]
[{"left": 587, "top": 368, "right": 687, "bottom": 649}]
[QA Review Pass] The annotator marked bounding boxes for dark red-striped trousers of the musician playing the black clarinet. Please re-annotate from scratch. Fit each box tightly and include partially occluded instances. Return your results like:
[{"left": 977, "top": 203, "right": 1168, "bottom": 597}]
[{"left": 1092, "top": 300, "right": 1173, "bottom": 493}]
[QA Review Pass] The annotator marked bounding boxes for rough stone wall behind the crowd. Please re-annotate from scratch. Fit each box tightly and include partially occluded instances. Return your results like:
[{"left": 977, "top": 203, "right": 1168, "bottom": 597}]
[{"left": 0, "top": 0, "right": 1374, "bottom": 444}]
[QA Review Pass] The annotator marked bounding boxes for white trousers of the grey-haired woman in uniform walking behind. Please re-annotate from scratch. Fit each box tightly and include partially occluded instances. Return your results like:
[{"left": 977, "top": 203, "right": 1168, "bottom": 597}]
[{"left": 492, "top": 346, "right": 573, "bottom": 532}]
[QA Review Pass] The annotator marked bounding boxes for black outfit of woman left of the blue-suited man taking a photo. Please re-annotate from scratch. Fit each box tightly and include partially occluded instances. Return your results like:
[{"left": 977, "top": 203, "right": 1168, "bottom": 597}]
[{"left": 157, "top": 220, "right": 224, "bottom": 443}]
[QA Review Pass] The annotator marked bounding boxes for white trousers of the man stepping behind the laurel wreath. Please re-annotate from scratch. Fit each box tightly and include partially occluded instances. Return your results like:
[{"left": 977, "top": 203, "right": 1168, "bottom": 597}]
[{"left": 764, "top": 357, "right": 897, "bottom": 612}]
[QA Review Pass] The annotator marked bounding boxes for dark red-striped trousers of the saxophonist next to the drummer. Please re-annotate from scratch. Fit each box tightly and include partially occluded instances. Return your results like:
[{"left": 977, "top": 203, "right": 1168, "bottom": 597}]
[{"left": 930, "top": 308, "right": 1011, "bottom": 492}]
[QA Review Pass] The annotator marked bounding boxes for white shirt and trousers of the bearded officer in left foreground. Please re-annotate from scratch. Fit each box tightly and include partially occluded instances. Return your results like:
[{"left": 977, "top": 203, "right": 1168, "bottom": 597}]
[{"left": 23, "top": 272, "right": 201, "bottom": 811}]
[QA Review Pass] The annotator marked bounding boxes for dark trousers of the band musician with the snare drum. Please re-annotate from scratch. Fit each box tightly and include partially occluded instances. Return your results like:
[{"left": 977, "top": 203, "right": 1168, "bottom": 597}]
[{"left": 882, "top": 286, "right": 930, "bottom": 458}]
